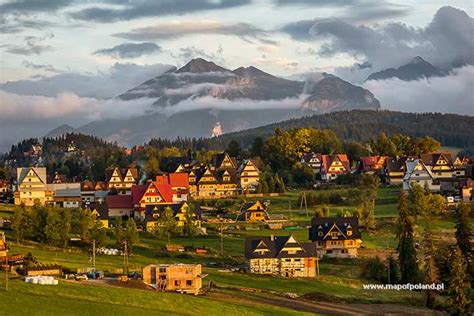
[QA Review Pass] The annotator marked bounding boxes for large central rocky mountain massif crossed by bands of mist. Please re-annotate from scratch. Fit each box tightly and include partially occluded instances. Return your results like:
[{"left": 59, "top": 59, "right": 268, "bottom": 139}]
[{"left": 44, "top": 58, "right": 380, "bottom": 145}]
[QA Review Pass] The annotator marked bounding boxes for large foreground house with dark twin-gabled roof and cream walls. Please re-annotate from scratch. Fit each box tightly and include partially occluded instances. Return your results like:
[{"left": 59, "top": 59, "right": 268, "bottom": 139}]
[{"left": 245, "top": 235, "right": 319, "bottom": 277}]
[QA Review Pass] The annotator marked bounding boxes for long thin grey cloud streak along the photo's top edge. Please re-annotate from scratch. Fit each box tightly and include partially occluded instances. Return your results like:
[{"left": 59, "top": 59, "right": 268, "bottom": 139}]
[{"left": 71, "top": 0, "right": 251, "bottom": 22}]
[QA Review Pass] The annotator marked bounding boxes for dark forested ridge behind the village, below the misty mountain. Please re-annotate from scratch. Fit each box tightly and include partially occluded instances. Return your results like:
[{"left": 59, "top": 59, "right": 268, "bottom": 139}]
[{"left": 214, "top": 110, "right": 474, "bottom": 153}]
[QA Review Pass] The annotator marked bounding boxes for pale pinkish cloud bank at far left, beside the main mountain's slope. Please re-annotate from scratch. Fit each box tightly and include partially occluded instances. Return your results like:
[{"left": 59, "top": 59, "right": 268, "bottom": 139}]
[{"left": 0, "top": 90, "right": 159, "bottom": 152}]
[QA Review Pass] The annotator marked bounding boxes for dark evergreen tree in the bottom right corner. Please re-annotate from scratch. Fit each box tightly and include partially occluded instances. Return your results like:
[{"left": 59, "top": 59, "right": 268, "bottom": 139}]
[{"left": 447, "top": 248, "right": 471, "bottom": 315}]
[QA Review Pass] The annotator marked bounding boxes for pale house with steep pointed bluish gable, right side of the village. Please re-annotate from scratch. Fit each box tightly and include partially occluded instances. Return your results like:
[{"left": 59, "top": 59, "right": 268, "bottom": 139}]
[{"left": 403, "top": 159, "right": 441, "bottom": 191}]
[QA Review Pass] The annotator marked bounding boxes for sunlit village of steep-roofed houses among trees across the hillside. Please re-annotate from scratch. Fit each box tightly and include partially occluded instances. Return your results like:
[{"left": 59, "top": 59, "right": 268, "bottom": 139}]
[{"left": 0, "top": 129, "right": 474, "bottom": 311}]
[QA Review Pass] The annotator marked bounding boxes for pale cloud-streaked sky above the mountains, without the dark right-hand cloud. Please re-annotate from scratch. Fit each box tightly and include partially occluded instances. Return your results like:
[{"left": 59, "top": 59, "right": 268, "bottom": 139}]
[{"left": 0, "top": 0, "right": 473, "bottom": 82}]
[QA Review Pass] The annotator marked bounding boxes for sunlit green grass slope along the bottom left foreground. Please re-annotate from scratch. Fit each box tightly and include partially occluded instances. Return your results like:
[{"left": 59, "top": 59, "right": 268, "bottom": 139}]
[{"left": 0, "top": 280, "right": 308, "bottom": 316}]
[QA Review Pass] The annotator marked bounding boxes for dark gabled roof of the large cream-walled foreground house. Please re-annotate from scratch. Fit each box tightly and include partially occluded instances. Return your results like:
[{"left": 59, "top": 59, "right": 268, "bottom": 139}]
[{"left": 245, "top": 236, "right": 316, "bottom": 259}]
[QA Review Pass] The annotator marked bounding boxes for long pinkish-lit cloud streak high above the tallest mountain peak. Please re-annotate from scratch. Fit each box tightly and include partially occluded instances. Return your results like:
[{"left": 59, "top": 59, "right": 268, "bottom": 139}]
[{"left": 115, "top": 20, "right": 267, "bottom": 41}]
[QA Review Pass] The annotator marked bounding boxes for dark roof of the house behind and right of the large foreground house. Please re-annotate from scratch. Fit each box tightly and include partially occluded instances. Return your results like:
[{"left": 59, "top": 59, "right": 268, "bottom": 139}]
[{"left": 309, "top": 216, "right": 361, "bottom": 241}]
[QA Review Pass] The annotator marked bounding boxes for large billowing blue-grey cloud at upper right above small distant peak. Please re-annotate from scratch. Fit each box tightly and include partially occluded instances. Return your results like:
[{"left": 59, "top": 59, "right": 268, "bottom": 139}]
[{"left": 310, "top": 7, "right": 474, "bottom": 71}]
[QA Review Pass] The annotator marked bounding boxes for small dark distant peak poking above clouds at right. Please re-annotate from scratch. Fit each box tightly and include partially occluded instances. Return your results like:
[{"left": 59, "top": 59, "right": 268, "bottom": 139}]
[{"left": 366, "top": 56, "right": 446, "bottom": 81}]
